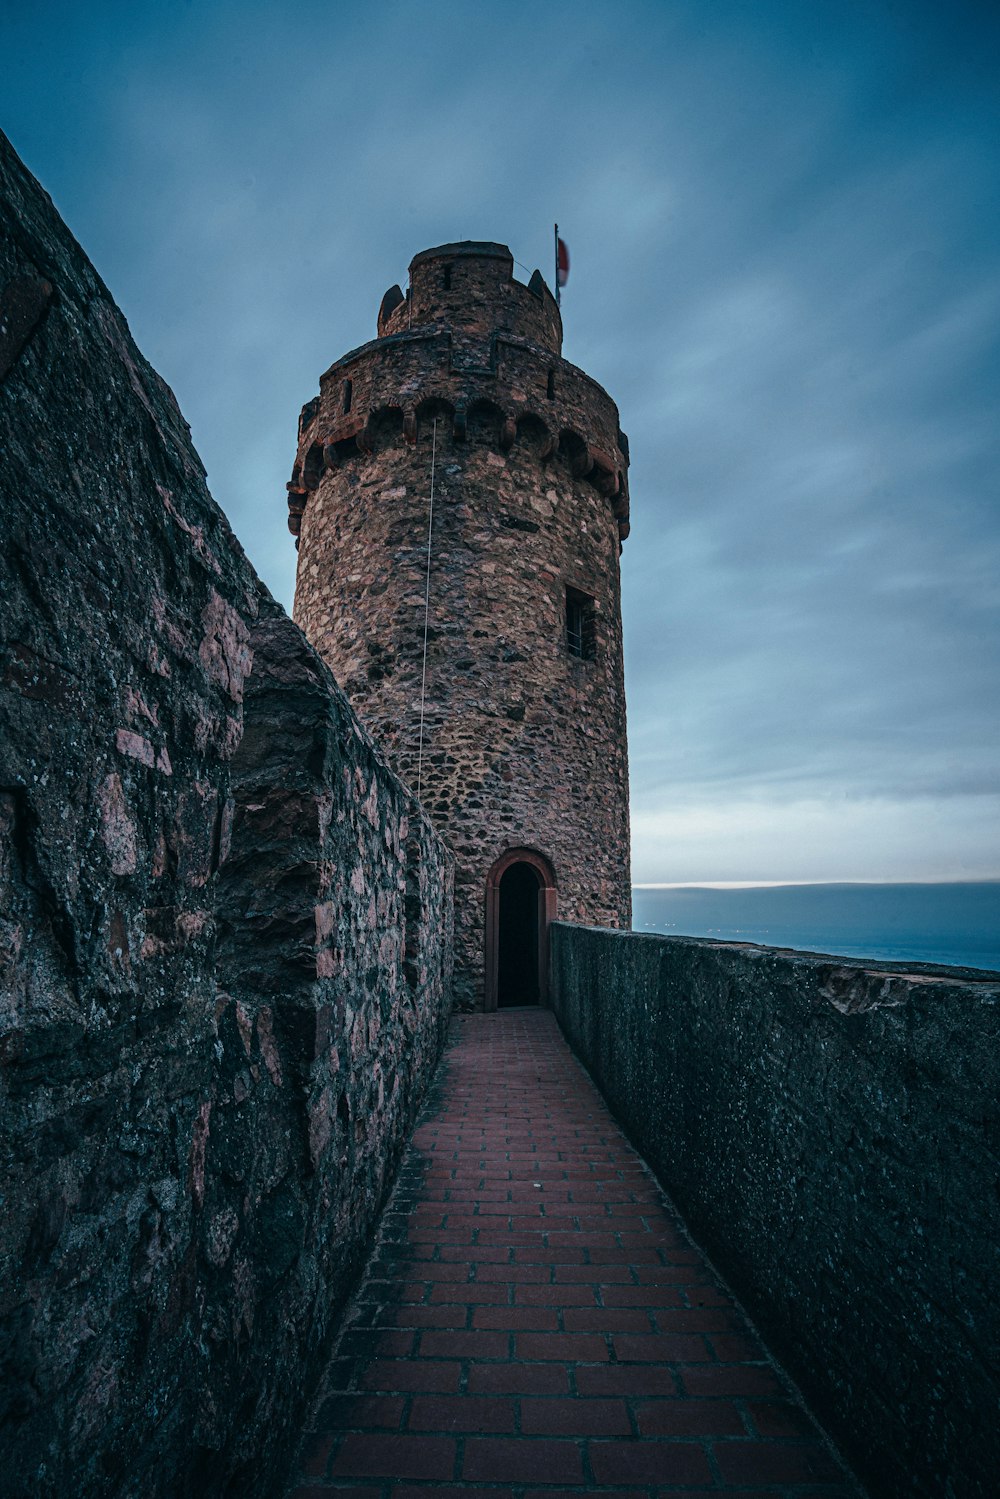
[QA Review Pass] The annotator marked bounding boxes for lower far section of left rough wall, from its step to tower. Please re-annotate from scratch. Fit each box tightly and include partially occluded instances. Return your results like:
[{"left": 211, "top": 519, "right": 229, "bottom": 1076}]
[{"left": 193, "top": 616, "right": 451, "bottom": 1493}]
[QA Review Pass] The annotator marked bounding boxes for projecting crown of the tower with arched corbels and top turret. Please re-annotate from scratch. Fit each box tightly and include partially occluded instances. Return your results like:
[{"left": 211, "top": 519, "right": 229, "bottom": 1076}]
[{"left": 288, "top": 243, "right": 628, "bottom": 541}]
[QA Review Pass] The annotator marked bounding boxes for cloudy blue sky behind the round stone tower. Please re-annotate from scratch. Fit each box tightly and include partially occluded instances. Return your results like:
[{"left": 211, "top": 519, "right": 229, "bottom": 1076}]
[{"left": 0, "top": 0, "right": 1000, "bottom": 881}]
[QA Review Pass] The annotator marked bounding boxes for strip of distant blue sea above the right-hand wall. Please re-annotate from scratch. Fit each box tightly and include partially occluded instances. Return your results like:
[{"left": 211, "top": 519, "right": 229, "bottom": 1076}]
[{"left": 633, "top": 880, "right": 1000, "bottom": 970}]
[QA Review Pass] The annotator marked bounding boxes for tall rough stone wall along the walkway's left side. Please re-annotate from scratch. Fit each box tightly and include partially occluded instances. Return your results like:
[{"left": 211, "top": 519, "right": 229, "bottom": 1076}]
[{"left": 0, "top": 136, "right": 451, "bottom": 1499}]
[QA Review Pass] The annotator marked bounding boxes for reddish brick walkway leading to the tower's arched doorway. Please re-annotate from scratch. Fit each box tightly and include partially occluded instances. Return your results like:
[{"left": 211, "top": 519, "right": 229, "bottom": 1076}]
[{"left": 284, "top": 1010, "right": 856, "bottom": 1499}]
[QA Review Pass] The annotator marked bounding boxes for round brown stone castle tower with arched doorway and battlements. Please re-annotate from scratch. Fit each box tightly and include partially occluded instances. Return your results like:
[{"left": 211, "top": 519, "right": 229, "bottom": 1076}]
[{"left": 288, "top": 243, "right": 631, "bottom": 1009}]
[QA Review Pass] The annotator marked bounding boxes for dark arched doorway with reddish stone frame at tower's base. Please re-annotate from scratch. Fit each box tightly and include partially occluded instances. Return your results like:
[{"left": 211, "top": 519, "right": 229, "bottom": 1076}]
[{"left": 486, "top": 848, "right": 556, "bottom": 1010}]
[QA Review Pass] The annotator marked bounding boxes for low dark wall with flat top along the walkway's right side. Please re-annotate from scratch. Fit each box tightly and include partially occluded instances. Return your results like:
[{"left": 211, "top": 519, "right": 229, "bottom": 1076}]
[{"left": 552, "top": 925, "right": 1000, "bottom": 1499}]
